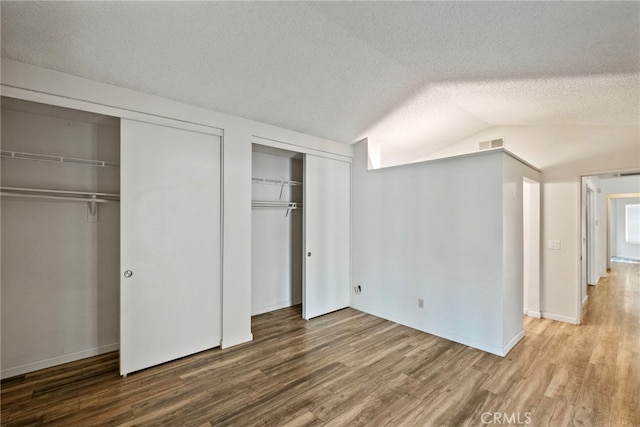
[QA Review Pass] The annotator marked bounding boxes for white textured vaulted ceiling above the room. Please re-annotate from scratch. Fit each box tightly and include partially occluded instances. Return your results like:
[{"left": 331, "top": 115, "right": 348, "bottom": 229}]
[{"left": 1, "top": 1, "right": 640, "bottom": 155}]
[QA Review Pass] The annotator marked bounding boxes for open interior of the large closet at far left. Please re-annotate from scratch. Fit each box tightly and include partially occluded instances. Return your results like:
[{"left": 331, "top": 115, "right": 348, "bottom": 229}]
[{"left": 1, "top": 97, "right": 120, "bottom": 378}]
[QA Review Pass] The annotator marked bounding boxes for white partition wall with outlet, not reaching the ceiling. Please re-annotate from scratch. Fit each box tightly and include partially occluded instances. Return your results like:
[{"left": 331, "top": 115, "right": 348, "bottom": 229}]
[{"left": 352, "top": 142, "right": 536, "bottom": 354}]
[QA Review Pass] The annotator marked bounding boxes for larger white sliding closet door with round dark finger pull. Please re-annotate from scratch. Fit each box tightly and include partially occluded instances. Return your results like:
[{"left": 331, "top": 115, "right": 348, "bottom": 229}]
[{"left": 120, "top": 120, "right": 221, "bottom": 375}]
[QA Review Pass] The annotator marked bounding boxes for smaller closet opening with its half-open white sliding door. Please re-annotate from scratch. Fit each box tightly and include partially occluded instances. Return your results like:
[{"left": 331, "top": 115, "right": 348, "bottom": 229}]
[{"left": 251, "top": 143, "right": 351, "bottom": 320}]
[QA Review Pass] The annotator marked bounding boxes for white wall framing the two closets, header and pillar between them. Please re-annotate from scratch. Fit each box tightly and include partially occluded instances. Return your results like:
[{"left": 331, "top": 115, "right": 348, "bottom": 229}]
[{"left": 0, "top": 59, "right": 353, "bottom": 354}]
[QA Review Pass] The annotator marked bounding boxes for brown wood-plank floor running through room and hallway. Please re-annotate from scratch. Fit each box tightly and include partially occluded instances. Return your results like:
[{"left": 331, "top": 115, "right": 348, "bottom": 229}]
[{"left": 1, "top": 263, "right": 640, "bottom": 426}]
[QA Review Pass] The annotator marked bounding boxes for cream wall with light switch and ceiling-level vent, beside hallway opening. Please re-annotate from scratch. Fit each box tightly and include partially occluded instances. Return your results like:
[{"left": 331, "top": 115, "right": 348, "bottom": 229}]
[{"left": 408, "top": 126, "right": 640, "bottom": 323}]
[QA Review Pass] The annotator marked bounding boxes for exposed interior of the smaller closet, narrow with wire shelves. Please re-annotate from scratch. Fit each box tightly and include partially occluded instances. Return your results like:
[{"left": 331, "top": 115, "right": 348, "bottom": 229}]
[{"left": 251, "top": 144, "right": 304, "bottom": 315}]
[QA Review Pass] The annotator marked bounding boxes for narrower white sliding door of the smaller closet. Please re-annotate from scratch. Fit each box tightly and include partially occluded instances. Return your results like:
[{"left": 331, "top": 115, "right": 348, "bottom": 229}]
[{"left": 302, "top": 155, "right": 351, "bottom": 319}]
